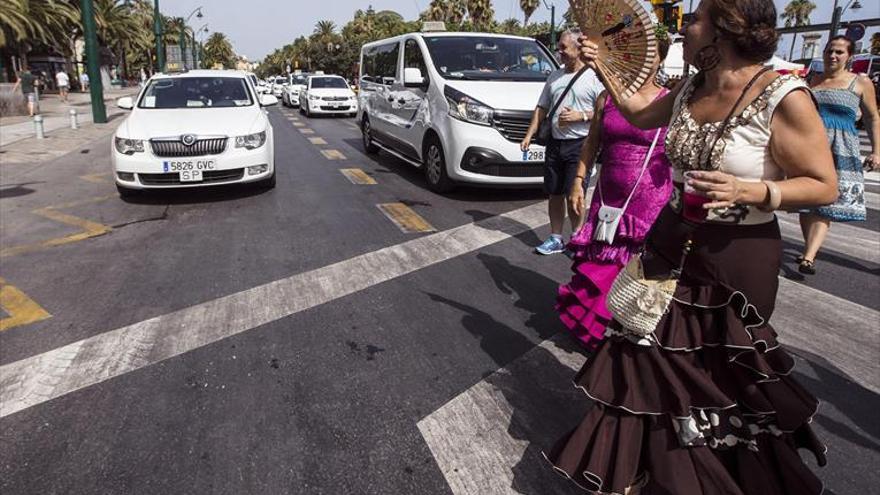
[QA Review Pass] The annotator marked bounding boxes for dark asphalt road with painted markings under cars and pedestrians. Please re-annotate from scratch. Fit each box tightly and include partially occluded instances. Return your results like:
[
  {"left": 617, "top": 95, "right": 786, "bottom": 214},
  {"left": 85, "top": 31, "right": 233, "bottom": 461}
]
[{"left": 0, "top": 107, "right": 880, "bottom": 495}]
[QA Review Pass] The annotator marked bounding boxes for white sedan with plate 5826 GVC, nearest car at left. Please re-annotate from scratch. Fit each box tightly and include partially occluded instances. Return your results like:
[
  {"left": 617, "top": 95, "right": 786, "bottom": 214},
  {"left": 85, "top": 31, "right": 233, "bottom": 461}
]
[{"left": 111, "top": 70, "right": 278, "bottom": 197}]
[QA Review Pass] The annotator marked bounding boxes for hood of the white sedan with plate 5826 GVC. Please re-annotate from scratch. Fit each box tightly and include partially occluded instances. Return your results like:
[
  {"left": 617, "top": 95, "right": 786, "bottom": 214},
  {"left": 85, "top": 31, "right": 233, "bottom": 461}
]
[{"left": 117, "top": 106, "right": 267, "bottom": 139}]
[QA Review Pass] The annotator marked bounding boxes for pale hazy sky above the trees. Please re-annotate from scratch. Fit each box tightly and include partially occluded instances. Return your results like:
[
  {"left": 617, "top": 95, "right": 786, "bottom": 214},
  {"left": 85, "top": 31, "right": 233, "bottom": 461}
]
[{"left": 159, "top": 0, "right": 880, "bottom": 61}]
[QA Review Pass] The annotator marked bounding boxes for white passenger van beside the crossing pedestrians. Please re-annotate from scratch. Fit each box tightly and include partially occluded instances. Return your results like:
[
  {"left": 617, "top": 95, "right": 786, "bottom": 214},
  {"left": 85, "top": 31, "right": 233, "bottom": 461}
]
[{"left": 358, "top": 32, "right": 558, "bottom": 192}]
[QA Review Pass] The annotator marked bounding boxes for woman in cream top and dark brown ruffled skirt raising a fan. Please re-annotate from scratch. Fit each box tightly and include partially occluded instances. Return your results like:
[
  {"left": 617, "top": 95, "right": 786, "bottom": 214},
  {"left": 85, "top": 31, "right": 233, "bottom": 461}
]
[{"left": 546, "top": 0, "right": 837, "bottom": 495}]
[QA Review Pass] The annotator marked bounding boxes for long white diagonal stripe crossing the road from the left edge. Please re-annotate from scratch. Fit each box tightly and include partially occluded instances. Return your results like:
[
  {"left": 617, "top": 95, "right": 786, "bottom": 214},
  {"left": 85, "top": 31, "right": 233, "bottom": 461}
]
[{"left": 0, "top": 202, "right": 547, "bottom": 417}]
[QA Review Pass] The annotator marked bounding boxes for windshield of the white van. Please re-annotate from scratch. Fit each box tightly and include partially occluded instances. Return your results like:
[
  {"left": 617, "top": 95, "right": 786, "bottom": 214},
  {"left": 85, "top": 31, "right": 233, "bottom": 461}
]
[{"left": 424, "top": 36, "right": 556, "bottom": 81}]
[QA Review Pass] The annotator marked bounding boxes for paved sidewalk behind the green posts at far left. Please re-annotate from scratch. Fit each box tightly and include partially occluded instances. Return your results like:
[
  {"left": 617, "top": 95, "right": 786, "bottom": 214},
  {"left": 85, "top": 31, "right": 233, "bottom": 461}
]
[{"left": 0, "top": 87, "right": 138, "bottom": 147}]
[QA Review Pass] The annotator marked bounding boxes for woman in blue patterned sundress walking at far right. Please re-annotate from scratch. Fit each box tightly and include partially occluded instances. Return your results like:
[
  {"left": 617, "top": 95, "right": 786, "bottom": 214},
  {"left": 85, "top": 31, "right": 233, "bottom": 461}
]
[{"left": 798, "top": 36, "right": 880, "bottom": 275}]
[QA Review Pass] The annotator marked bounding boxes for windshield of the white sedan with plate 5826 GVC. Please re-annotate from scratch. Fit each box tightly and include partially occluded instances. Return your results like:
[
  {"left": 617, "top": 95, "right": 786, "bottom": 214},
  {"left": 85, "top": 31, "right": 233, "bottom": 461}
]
[{"left": 138, "top": 77, "right": 254, "bottom": 109}]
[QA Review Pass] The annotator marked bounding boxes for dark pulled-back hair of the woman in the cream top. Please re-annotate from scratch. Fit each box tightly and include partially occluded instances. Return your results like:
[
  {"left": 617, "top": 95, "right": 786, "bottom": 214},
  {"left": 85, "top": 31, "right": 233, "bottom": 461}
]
[{"left": 709, "top": 0, "right": 779, "bottom": 62}]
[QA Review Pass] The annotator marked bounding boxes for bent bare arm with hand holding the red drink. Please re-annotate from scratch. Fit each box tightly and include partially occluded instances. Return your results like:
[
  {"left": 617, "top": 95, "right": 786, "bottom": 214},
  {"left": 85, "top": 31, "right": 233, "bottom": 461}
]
[{"left": 688, "top": 91, "right": 837, "bottom": 209}]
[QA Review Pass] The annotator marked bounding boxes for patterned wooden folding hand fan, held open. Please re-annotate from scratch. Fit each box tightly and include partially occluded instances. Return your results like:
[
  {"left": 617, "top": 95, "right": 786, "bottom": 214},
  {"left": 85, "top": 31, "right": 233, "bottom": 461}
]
[{"left": 569, "top": 0, "right": 657, "bottom": 101}]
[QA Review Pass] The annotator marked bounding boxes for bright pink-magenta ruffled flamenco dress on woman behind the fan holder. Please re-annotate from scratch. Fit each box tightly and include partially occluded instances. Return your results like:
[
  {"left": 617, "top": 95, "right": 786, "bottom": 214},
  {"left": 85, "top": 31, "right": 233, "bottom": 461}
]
[{"left": 556, "top": 93, "right": 672, "bottom": 352}]
